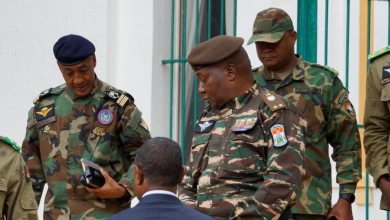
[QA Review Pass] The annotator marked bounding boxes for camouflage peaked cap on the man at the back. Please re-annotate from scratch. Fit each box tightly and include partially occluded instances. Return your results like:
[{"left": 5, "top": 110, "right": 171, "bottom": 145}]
[{"left": 248, "top": 8, "right": 294, "bottom": 45}]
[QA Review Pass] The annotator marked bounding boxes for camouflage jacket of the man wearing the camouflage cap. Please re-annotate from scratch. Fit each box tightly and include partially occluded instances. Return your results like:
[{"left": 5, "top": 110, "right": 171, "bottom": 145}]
[{"left": 253, "top": 55, "right": 361, "bottom": 215}]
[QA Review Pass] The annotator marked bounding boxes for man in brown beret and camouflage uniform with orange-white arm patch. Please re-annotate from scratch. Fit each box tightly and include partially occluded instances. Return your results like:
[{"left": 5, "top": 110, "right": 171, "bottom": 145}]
[{"left": 179, "top": 36, "right": 306, "bottom": 220}]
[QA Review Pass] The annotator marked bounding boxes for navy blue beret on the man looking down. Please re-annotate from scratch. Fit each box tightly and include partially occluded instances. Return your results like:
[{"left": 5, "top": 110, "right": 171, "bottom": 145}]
[{"left": 53, "top": 34, "right": 95, "bottom": 66}]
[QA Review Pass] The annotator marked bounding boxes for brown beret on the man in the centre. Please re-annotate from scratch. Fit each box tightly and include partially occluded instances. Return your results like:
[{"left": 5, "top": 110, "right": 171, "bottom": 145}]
[{"left": 187, "top": 35, "right": 244, "bottom": 71}]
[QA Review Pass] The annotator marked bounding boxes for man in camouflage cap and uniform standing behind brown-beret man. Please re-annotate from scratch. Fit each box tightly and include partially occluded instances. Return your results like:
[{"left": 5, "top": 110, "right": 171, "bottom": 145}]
[{"left": 248, "top": 8, "right": 361, "bottom": 220}]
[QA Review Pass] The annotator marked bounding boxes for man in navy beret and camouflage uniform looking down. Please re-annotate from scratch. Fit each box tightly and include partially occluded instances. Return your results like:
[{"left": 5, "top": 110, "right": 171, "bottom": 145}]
[{"left": 22, "top": 35, "right": 150, "bottom": 219}]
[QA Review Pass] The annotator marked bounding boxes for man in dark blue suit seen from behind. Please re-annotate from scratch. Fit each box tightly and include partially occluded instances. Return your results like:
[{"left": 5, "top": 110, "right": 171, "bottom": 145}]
[{"left": 108, "top": 137, "right": 213, "bottom": 220}]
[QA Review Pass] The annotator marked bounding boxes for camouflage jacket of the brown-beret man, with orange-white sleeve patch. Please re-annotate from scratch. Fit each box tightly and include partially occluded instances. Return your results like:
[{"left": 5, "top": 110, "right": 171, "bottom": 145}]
[{"left": 179, "top": 83, "right": 306, "bottom": 219}]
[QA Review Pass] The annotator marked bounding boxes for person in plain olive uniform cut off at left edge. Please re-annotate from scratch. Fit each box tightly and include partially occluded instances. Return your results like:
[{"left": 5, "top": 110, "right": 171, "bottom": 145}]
[{"left": 0, "top": 136, "right": 38, "bottom": 220}]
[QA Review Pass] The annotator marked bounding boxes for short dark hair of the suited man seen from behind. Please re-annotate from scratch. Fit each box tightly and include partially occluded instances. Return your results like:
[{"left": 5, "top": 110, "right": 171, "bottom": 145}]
[{"left": 134, "top": 137, "right": 182, "bottom": 186}]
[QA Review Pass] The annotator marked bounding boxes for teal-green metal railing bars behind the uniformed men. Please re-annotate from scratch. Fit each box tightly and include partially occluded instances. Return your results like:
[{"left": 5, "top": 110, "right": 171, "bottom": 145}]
[{"left": 161, "top": 0, "right": 390, "bottom": 220}]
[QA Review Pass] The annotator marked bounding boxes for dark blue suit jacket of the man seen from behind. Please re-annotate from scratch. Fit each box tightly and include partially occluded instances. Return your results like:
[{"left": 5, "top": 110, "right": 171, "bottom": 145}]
[{"left": 107, "top": 194, "right": 214, "bottom": 220}]
